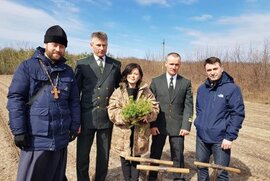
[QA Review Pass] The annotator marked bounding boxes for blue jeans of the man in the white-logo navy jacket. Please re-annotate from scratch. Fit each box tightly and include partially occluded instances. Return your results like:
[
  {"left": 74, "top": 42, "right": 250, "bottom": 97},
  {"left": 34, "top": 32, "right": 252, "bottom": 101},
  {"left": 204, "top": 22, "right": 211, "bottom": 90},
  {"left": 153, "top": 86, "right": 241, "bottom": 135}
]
[{"left": 196, "top": 137, "right": 231, "bottom": 181}]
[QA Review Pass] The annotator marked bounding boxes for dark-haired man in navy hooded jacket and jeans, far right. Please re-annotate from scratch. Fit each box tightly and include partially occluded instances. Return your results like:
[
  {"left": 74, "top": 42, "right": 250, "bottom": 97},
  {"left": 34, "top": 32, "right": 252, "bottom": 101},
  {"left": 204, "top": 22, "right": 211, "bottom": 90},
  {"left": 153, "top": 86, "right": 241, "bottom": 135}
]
[{"left": 194, "top": 57, "right": 245, "bottom": 180}]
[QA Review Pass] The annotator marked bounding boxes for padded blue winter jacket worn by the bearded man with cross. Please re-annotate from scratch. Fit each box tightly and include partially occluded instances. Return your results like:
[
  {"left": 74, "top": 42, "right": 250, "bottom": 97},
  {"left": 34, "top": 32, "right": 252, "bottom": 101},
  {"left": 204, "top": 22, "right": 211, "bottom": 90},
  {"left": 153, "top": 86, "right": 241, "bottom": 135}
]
[{"left": 7, "top": 47, "right": 80, "bottom": 151}]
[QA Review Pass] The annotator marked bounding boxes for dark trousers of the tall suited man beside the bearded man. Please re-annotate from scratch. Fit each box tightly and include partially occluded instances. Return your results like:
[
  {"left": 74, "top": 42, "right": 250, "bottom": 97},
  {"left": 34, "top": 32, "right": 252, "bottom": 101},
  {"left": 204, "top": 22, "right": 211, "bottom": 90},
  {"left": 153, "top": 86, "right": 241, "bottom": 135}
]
[{"left": 77, "top": 128, "right": 112, "bottom": 181}]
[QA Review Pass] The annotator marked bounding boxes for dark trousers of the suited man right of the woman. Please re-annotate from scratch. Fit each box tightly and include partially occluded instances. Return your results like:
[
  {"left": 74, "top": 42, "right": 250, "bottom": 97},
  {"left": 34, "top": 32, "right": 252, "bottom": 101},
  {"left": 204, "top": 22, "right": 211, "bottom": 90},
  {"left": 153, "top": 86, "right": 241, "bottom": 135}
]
[{"left": 149, "top": 134, "right": 184, "bottom": 181}]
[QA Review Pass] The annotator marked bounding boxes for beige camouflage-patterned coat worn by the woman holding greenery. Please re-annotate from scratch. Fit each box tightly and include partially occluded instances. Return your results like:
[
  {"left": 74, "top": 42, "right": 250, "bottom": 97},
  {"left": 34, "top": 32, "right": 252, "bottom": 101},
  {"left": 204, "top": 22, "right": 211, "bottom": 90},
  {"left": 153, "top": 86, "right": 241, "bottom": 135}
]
[{"left": 108, "top": 83, "right": 159, "bottom": 157}]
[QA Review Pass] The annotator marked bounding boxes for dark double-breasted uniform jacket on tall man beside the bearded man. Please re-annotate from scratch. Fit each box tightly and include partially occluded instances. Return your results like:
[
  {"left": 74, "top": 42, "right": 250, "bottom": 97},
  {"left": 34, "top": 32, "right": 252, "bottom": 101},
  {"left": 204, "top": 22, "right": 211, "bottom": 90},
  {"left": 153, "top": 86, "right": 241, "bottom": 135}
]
[{"left": 75, "top": 55, "right": 121, "bottom": 129}]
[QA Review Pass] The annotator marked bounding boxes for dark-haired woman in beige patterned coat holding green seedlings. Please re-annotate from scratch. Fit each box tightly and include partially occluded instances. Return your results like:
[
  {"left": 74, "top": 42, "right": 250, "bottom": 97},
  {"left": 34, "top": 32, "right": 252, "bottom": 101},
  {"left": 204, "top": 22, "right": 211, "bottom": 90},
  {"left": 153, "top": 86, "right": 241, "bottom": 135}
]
[{"left": 108, "top": 63, "right": 159, "bottom": 181}]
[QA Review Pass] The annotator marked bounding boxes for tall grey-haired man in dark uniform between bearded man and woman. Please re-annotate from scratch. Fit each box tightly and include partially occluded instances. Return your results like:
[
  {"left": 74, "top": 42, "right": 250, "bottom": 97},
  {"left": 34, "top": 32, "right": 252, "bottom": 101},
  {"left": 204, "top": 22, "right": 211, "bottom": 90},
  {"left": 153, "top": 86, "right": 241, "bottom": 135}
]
[{"left": 75, "top": 32, "right": 121, "bottom": 181}]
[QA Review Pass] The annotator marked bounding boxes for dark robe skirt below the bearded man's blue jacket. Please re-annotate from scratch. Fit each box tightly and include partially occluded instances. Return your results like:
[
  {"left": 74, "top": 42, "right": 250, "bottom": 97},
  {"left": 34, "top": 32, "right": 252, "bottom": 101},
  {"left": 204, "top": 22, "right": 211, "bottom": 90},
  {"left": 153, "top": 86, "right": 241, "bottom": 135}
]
[{"left": 17, "top": 148, "right": 67, "bottom": 181}]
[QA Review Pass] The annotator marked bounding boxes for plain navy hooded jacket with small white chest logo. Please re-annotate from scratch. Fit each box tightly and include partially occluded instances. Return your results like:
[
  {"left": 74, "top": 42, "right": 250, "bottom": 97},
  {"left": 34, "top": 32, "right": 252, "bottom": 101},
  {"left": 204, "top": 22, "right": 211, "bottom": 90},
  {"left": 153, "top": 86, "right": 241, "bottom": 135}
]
[{"left": 194, "top": 72, "right": 245, "bottom": 143}]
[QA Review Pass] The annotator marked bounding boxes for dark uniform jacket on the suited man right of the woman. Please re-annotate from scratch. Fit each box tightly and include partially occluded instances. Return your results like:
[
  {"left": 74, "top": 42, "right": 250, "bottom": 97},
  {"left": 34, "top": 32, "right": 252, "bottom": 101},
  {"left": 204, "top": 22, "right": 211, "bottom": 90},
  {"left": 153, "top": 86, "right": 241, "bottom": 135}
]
[{"left": 150, "top": 73, "right": 193, "bottom": 136}]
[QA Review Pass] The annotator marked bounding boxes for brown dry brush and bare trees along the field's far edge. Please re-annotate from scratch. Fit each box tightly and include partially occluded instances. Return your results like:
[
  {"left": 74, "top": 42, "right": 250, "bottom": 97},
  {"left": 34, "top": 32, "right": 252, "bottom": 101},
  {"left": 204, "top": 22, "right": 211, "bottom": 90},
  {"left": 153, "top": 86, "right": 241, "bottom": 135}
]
[{"left": 0, "top": 46, "right": 270, "bottom": 104}]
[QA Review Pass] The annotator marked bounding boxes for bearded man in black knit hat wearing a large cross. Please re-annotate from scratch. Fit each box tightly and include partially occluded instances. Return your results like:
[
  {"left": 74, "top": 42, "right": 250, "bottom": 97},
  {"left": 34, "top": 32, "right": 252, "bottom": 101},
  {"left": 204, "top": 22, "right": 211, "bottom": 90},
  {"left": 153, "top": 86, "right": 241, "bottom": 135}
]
[{"left": 7, "top": 25, "right": 80, "bottom": 181}]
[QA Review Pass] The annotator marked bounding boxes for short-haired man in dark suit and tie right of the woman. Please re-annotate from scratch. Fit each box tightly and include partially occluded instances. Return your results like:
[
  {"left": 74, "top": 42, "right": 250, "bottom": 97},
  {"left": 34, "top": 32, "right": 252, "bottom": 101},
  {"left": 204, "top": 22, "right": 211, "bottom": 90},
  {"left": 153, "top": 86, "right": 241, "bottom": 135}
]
[{"left": 149, "top": 52, "right": 193, "bottom": 181}]
